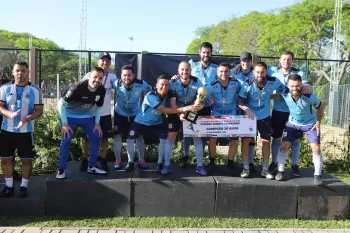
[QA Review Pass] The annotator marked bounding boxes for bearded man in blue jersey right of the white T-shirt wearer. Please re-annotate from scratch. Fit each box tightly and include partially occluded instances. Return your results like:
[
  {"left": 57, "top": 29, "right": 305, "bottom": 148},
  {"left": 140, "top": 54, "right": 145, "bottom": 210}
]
[{"left": 112, "top": 65, "right": 151, "bottom": 169}]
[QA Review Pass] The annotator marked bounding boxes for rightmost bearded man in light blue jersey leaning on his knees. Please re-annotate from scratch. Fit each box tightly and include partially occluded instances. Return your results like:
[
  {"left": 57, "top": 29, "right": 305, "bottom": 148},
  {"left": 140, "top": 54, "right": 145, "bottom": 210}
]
[{"left": 276, "top": 74, "right": 324, "bottom": 185}]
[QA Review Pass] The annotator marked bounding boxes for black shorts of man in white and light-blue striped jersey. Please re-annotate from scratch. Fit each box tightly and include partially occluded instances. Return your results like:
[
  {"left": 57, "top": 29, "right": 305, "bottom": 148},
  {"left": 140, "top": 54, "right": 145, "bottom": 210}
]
[{"left": 0, "top": 130, "right": 34, "bottom": 160}]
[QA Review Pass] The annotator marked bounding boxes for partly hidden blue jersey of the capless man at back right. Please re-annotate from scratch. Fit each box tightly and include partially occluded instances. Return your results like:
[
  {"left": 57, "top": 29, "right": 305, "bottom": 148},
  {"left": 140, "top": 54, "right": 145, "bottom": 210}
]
[{"left": 267, "top": 66, "right": 307, "bottom": 112}]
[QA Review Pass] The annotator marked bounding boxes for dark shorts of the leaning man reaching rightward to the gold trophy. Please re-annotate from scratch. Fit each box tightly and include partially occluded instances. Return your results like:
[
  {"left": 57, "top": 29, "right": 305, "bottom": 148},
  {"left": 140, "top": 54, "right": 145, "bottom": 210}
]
[{"left": 126, "top": 121, "right": 167, "bottom": 139}]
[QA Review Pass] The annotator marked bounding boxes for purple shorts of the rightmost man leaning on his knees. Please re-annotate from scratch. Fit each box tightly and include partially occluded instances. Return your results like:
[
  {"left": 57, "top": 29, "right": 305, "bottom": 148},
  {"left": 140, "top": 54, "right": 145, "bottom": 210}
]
[{"left": 282, "top": 122, "right": 321, "bottom": 144}]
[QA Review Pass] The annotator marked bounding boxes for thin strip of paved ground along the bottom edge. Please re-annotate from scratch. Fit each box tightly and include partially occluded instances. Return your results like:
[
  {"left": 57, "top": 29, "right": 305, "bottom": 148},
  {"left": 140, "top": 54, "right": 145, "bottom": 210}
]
[{"left": 0, "top": 227, "right": 350, "bottom": 233}]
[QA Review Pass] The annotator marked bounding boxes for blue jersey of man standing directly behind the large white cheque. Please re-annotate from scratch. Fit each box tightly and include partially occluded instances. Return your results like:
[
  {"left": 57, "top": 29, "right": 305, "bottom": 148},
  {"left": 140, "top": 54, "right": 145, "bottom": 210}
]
[{"left": 207, "top": 79, "right": 241, "bottom": 116}]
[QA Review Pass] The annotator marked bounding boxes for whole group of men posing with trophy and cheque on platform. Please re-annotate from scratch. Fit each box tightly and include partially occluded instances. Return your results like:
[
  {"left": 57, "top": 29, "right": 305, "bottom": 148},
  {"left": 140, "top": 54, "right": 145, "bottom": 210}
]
[{"left": 0, "top": 42, "right": 324, "bottom": 198}]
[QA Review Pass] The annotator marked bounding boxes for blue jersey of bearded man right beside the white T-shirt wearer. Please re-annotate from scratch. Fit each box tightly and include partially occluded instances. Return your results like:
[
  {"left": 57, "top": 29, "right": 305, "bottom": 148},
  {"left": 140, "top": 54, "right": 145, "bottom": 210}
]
[{"left": 112, "top": 79, "right": 151, "bottom": 117}]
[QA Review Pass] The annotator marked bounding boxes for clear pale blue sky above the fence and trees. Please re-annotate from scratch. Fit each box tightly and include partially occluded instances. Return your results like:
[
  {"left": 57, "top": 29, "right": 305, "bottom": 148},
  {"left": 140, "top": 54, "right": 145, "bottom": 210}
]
[{"left": 0, "top": 0, "right": 299, "bottom": 53}]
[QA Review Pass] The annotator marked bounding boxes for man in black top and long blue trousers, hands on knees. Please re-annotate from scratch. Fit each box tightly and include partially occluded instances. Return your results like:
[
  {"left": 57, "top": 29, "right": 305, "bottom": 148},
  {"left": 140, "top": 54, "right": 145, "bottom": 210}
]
[{"left": 56, "top": 67, "right": 106, "bottom": 179}]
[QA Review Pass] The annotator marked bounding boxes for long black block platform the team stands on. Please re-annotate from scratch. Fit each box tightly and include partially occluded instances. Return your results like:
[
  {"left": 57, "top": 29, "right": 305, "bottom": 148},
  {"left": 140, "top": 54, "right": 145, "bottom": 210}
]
[{"left": 0, "top": 162, "right": 350, "bottom": 220}]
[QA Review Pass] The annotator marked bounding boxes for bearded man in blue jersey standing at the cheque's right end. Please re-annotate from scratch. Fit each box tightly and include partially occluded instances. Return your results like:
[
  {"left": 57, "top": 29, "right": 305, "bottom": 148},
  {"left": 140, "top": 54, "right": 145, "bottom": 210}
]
[{"left": 239, "top": 62, "right": 284, "bottom": 179}]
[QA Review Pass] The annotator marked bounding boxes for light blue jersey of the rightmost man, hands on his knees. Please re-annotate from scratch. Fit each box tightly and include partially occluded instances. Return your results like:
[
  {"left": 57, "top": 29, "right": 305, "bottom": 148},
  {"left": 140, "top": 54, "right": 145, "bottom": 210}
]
[{"left": 282, "top": 88, "right": 321, "bottom": 126}]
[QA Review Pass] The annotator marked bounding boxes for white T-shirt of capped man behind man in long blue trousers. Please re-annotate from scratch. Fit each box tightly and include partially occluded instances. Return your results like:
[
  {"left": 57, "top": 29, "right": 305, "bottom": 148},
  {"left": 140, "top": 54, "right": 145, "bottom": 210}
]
[{"left": 83, "top": 71, "right": 118, "bottom": 116}]
